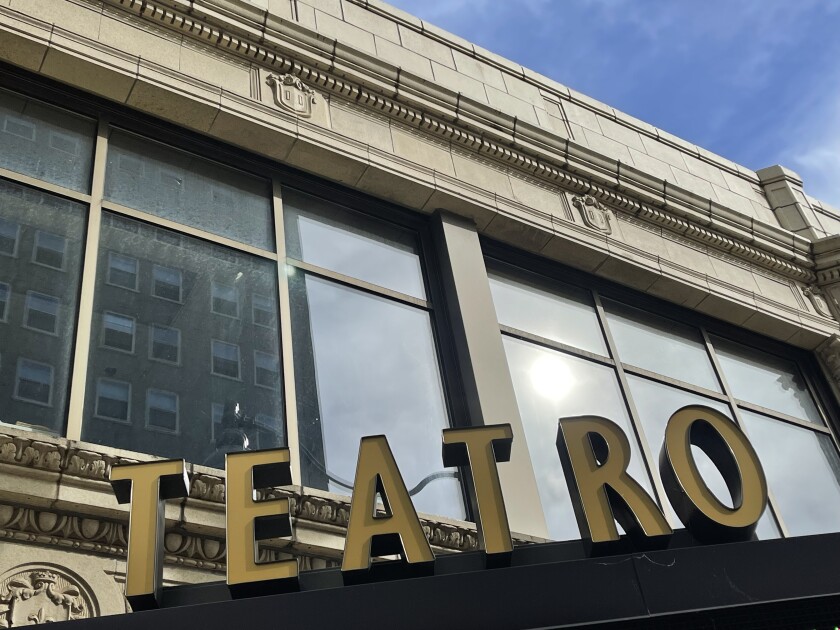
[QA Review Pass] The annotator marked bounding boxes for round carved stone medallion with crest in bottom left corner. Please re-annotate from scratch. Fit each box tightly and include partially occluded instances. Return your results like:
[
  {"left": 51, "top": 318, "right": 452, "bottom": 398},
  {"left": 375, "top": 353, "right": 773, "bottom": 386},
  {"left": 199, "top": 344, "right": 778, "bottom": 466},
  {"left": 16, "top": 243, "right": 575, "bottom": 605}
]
[{"left": 0, "top": 565, "right": 98, "bottom": 628}]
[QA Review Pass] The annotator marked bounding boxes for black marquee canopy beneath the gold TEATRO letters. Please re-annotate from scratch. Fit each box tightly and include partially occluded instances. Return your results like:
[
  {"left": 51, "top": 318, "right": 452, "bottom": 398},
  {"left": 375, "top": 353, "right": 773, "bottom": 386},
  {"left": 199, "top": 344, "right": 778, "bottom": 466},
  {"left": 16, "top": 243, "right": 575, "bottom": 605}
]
[{"left": 55, "top": 531, "right": 840, "bottom": 630}]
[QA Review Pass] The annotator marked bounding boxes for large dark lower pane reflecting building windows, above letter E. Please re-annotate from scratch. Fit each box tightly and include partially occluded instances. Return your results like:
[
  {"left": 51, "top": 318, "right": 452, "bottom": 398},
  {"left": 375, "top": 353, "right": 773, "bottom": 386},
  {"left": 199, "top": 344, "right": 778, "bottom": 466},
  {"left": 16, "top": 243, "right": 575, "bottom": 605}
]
[{"left": 82, "top": 212, "right": 284, "bottom": 468}]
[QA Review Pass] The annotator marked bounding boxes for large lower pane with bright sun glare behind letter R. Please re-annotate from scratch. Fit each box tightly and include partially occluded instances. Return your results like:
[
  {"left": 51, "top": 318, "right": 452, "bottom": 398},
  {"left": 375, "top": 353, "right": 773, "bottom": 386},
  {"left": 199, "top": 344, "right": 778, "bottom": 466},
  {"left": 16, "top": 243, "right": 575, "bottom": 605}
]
[{"left": 504, "top": 337, "right": 651, "bottom": 540}]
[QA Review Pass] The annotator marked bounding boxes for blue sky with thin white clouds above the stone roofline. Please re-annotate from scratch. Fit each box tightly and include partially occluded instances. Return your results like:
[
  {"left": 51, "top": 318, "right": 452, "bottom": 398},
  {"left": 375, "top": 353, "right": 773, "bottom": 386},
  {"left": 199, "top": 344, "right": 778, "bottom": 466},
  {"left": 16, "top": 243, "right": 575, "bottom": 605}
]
[{"left": 390, "top": 0, "right": 840, "bottom": 208}]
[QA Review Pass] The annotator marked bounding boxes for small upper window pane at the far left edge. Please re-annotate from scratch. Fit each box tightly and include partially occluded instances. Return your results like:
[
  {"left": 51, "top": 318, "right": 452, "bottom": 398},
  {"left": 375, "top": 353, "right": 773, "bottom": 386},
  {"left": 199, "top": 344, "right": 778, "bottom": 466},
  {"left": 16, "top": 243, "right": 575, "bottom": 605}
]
[{"left": 0, "top": 90, "right": 96, "bottom": 192}]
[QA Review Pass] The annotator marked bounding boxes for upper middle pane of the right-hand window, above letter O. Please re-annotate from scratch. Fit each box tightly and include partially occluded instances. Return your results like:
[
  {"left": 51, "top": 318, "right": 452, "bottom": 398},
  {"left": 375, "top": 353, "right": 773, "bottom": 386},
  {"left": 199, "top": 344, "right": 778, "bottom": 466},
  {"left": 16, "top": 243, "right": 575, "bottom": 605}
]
[{"left": 604, "top": 300, "right": 721, "bottom": 392}]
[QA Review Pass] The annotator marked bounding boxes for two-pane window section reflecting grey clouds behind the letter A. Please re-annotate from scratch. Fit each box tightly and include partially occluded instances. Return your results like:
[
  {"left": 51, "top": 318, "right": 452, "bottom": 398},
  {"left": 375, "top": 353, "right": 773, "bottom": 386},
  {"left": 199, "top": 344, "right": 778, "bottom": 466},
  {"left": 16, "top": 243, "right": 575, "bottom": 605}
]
[{"left": 283, "top": 191, "right": 465, "bottom": 518}]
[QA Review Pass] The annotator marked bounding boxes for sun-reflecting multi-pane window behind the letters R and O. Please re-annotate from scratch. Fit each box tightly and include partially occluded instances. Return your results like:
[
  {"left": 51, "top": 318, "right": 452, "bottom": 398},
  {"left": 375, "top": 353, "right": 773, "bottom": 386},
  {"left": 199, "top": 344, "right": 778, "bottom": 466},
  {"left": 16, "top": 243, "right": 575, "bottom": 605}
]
[{"left": 490, "top": 262, "right": 840, "bottom": 539}]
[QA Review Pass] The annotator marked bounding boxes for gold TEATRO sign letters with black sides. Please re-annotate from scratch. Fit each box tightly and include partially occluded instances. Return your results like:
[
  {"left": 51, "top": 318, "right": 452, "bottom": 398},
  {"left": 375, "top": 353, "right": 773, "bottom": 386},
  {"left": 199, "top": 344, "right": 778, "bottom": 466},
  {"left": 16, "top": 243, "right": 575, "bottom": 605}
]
[{"left": 111, "top": 406, "right": 767, "bottom": 610}]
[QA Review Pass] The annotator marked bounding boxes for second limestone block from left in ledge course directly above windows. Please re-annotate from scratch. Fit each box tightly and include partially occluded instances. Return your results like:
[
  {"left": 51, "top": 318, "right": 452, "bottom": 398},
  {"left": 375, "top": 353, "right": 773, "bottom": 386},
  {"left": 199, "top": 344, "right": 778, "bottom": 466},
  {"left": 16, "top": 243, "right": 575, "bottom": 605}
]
[{"left": 40, "top": 33, "right": 138, "bottom": 103}]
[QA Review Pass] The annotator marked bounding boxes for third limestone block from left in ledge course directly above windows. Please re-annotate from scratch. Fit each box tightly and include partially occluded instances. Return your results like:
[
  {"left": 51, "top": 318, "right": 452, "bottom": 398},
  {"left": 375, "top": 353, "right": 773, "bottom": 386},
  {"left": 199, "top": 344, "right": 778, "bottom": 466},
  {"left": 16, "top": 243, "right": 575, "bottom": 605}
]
[{"left": 127, "top": 60, "right": 221, "bottom": 132}]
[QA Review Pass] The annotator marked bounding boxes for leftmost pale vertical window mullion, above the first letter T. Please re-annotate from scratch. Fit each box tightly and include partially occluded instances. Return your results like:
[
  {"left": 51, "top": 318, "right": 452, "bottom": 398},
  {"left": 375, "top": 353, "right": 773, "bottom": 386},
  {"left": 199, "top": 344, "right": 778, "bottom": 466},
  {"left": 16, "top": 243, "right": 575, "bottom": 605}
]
[{"left": 66, "top": 118, "right": 109, "bottom": 440}]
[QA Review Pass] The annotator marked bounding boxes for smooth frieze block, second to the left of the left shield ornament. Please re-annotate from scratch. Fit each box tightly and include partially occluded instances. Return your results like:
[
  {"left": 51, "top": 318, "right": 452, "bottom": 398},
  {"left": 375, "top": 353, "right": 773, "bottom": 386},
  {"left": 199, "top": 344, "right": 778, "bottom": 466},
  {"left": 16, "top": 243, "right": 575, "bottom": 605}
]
[{"left": 99, "top": 11, "right": 183, "bottom": 70}]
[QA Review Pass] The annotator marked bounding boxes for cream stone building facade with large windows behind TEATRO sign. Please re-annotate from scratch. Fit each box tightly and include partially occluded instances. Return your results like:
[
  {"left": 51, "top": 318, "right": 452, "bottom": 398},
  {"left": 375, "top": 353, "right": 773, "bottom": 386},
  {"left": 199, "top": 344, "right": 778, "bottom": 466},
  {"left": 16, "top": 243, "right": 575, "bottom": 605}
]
[{"left": 0, "top": 0, "right": 840, "bottom": 626}]
